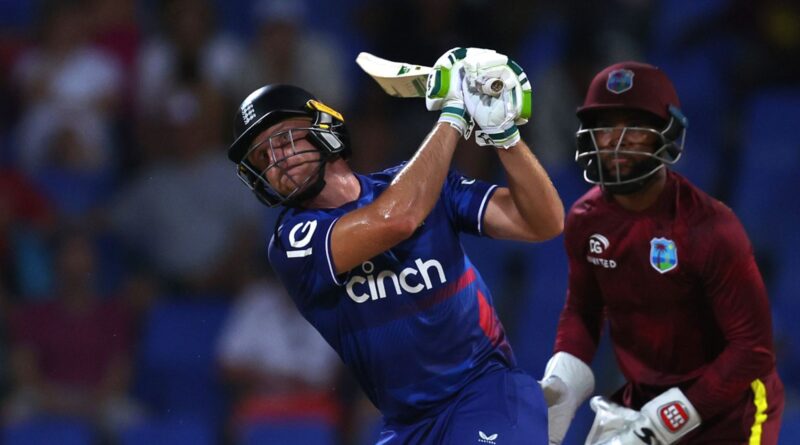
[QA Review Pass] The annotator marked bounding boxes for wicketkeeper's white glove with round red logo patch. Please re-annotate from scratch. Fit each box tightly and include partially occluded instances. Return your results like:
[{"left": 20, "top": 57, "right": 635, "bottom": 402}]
[{"left": 585, "top": 388, "right": 701, "bottom": 445}]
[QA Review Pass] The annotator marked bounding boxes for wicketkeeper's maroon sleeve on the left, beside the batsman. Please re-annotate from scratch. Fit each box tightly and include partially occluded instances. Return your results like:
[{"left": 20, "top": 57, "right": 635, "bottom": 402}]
[{"left": 554, "top": 212, "right": 603, "bottom": 364}]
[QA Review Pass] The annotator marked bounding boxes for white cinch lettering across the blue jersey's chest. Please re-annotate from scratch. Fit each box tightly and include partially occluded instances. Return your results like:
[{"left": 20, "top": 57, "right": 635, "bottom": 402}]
[{"left": 345, "top": 258, "right": 447, "bottom": 303}]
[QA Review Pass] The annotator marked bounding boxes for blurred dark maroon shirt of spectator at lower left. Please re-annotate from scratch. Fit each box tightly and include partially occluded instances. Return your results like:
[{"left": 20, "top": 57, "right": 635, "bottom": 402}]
[{"left": 10, "top": 301, "right": 133, "bottom": 387}]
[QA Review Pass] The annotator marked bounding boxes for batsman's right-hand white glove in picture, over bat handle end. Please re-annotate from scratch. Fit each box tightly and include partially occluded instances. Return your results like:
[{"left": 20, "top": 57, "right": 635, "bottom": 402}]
[{"left": 462, "top": 53, "right": 531, "bottom": 148}]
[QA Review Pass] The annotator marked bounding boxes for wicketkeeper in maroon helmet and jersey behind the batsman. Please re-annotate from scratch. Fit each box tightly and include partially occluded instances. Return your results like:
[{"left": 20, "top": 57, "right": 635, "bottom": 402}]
[{"left": 542, "top": 62, "right": 784, "bottom": 445}]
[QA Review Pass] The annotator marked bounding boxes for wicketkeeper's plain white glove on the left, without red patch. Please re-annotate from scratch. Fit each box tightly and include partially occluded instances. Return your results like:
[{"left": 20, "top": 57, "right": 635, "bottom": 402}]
[{"left": 540, "top": 352, "right": 594, "bottom": 445}]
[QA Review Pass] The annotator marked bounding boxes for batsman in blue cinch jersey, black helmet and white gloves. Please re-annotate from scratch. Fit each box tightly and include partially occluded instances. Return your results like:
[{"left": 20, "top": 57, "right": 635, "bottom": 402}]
[{"left": 228, "top": 48, "right": 564, "bottom": 445}]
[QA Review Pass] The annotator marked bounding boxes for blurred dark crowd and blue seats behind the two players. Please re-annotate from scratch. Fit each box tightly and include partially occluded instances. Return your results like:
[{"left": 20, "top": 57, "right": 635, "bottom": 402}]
[{"left": 0, "top": 0, "right": 800, "bottom": 445}]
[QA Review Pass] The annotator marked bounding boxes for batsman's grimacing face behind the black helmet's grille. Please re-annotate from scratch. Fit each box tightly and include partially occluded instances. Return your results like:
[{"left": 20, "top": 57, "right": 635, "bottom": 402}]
[{"left": 247, "top": 118, "right": 322, "bottom": 196}]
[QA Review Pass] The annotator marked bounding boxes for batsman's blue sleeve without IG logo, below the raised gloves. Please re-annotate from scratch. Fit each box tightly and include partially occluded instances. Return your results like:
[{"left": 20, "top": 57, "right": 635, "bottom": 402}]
[{"left": 442, "top": 171, "right": 497, "bottom": 236}]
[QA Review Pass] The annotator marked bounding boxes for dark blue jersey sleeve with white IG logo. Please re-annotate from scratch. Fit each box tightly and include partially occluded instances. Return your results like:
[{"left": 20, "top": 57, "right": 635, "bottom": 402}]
[{"left": 269, "top": 213, "right": 344, "bottom": 308}]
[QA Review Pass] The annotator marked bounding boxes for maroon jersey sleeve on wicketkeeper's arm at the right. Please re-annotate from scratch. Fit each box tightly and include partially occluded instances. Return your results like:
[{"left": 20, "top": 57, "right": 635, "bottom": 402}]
[{"left": 686, "top": 208, "right": 775, "bottom": 419}]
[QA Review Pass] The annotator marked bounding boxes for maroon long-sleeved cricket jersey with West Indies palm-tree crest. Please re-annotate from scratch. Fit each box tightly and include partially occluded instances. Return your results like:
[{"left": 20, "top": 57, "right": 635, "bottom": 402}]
[{"left": 555, "top": 171, "right": 775, "bottom": 418}]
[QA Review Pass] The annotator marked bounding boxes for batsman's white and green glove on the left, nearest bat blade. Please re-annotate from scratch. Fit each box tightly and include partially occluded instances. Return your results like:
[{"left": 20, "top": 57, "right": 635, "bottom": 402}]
[{"left": 425, "top": 47, "right": 494, "bottom": 139}]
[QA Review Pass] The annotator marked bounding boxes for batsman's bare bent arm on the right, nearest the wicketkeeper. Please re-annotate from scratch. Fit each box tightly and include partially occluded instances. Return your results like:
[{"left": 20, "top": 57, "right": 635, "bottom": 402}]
[{"left": 484, "top": 140, "right": 564, "bottom": 241}]
